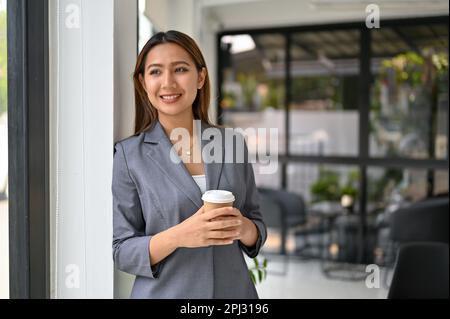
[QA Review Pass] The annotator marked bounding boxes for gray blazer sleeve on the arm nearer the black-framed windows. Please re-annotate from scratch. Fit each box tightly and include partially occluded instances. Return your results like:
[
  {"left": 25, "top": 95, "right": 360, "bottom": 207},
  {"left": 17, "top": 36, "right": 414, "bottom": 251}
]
[{"left": 239, "top": 140, "right": 267, "bottom": 258}]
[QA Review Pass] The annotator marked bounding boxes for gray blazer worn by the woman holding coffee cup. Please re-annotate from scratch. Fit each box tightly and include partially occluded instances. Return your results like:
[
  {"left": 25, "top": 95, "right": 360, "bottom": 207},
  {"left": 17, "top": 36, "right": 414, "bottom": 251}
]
[{"left": 112, "top": 121, "right": 267, "bottom": 298}]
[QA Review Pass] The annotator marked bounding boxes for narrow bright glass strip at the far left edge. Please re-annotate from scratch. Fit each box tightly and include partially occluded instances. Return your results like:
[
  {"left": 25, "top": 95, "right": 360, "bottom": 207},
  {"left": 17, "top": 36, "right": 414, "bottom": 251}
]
[{"left": 0, "top": 0, "right": 9, "bottom": 299}]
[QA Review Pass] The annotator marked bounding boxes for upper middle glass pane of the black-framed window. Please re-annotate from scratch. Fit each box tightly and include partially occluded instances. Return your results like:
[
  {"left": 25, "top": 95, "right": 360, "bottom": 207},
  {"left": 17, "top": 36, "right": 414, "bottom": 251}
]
[{"left": 289, "top": 30, "right": 359, "bottom": 156}]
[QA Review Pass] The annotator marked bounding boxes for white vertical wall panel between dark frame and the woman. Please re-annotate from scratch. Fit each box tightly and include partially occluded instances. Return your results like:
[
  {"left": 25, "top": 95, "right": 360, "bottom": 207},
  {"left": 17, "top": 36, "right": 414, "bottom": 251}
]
[{"left": 49, "top": 0, "right": 114, "bottom": 298}]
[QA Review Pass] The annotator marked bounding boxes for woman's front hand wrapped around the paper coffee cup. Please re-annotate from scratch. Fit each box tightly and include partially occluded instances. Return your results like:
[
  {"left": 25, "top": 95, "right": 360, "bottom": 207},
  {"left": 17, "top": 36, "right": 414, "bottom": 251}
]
[{"left": 175, "top": 206, "right": 241, "bottom": 248}]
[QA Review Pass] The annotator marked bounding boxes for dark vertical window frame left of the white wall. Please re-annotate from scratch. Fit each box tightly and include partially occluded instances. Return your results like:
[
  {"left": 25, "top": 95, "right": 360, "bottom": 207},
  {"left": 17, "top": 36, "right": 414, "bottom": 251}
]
[{"left": 7, "top": 0, "right": 50, "bottom": 299}]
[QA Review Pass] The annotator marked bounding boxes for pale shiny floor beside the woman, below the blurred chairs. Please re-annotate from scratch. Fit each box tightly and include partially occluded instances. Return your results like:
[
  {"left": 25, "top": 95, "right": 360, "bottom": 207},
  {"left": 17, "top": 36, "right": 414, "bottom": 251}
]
[{"left": 247, "top": 229, "right": 388, "bottom": 299}]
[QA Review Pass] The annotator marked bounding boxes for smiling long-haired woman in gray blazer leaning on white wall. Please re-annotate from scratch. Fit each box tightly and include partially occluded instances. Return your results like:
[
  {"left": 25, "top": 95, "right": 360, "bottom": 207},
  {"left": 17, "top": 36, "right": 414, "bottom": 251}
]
[{"left": 112, "top": 31, "right": 267, "bottom": 298}]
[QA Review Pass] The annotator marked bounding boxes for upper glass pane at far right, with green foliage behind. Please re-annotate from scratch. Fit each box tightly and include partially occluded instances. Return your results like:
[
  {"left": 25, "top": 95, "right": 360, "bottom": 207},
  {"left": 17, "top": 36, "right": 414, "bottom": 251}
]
[{"left": 369, "top": 24, "right": 448, "bottom": 159}]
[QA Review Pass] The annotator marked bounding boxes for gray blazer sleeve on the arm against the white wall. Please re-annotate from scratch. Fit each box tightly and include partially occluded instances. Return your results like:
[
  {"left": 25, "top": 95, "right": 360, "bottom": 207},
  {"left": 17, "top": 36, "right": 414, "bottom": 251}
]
[{"left": 112, "top": 143, "right": 162, "bottom": 278}]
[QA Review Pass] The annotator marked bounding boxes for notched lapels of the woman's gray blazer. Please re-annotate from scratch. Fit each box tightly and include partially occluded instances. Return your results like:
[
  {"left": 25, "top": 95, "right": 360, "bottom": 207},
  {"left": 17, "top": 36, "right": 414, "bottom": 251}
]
[{"left": 144, "top": 121, "right": 225, "bottom": 208}]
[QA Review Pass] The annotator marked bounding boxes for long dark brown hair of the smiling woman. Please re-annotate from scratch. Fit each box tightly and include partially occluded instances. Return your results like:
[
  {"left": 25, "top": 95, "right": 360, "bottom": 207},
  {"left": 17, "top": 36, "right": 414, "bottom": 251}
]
[{"left": 133, "top": 30, "right": 212, "bottom": 134}]
